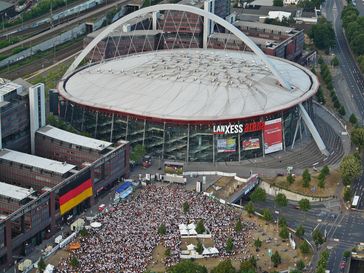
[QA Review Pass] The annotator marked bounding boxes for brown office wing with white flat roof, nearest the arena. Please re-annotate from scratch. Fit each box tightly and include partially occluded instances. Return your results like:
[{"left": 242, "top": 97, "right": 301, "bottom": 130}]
[{"left": 35, "top": 125, "right": 112, "bottom": 169}]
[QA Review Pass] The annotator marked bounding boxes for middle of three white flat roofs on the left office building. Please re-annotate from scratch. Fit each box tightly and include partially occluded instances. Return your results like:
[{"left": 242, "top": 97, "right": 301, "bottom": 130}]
[{"left": 0, "top": 149, "right": 76, "bottom": 174}]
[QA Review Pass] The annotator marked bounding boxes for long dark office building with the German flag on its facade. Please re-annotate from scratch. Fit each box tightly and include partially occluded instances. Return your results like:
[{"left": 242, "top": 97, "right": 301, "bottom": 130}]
[{"left": 0, "top": 140, "right": 129, "bottom": 268}]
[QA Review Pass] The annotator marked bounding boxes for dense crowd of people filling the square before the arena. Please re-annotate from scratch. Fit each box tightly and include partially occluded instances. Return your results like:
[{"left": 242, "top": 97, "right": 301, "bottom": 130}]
[{"left": 57, "top": 185, "right": 255, "bottom": 273}]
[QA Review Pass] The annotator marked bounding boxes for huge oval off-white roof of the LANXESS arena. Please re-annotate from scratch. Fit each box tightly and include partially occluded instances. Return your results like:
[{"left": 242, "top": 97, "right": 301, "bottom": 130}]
[{"left": 58, "top": 49, "right": 318, "bottom": 123}]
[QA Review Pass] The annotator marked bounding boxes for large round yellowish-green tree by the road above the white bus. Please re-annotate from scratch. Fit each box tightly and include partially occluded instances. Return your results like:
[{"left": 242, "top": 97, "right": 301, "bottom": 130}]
[{"left": 340, "top": 155, "right": 362, "bottom": 185}]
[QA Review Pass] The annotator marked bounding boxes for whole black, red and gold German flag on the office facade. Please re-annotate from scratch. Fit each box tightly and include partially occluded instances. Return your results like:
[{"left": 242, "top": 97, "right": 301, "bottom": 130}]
[{"left": 59, "top": 171, "right": 93, "bottom": 215}]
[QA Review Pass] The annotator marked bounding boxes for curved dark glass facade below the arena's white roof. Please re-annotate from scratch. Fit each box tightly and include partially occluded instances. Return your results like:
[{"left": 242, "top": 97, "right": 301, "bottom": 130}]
[{"left": 60, "top": 100, "right": 312, "bottom": 162}]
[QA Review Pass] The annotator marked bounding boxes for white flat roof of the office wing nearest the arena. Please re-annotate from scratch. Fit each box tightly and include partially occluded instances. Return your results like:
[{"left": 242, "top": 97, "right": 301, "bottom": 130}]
[{"left": 37, "top": 125, "right": 112, "bottom": 151}]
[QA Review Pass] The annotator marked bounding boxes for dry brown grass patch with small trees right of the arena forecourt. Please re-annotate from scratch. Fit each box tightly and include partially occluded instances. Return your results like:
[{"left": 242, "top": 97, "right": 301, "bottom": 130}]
[{"left": 263, "top": 171, "right": 340, "bottom": 198}]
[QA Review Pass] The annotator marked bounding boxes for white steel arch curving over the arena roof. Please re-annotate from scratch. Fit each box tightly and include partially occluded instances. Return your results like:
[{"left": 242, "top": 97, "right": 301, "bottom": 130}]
[{"left": 65, "top": 4, "right": 291, "bottom": 90}]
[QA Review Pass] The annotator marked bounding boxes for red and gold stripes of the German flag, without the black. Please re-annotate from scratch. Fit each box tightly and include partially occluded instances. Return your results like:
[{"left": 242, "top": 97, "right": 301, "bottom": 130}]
[{"left": 59, "top": 178, "right": 93, "bottom": 215}]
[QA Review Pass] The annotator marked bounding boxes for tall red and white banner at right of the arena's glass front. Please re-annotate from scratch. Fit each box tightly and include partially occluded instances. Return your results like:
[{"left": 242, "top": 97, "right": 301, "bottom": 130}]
[{"left": 264, "top": 118, "right": 283, "bottom": 154}]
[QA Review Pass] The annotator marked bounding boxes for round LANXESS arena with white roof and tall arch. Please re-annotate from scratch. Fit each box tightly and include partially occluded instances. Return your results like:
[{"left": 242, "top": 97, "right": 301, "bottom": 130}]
[{"left": 58, "top": 1, "right": 327, "bottom": 162}]
